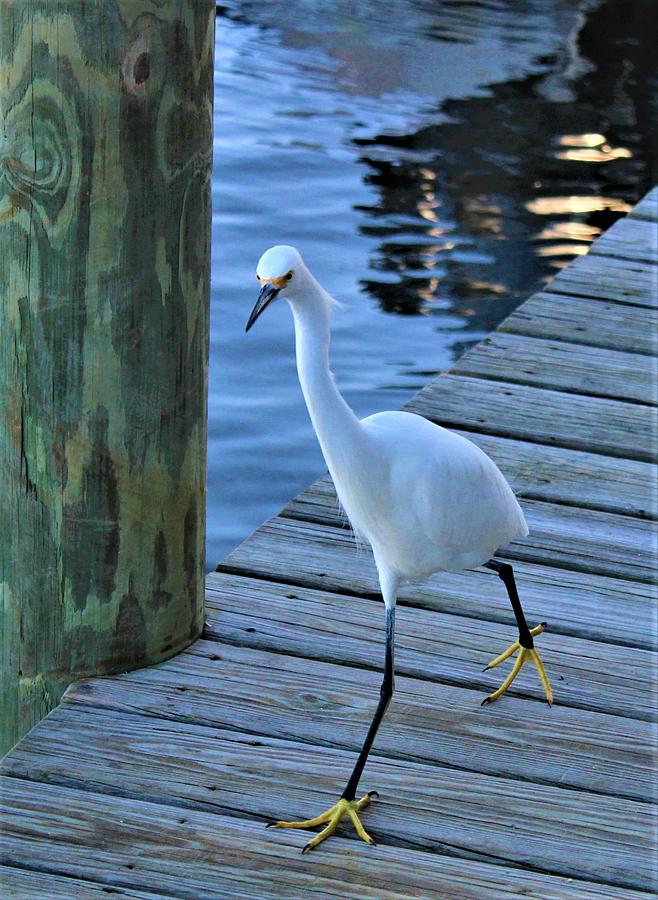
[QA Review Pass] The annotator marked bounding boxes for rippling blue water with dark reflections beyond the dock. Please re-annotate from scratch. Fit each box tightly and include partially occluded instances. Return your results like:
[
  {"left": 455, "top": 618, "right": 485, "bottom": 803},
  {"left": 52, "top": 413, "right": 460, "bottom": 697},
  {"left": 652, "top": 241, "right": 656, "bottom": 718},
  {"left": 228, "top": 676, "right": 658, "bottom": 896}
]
[{"left": 207, "top": 0, "right": 658, "bottom": 568}]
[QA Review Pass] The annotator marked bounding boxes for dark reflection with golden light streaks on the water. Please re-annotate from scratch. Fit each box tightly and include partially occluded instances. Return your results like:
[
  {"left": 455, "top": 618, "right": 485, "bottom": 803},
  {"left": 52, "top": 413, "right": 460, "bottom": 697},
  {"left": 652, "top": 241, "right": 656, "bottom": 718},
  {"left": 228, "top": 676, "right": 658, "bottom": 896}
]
[{"left": 348, "top": 0, "right": 656, "bottom": 332}]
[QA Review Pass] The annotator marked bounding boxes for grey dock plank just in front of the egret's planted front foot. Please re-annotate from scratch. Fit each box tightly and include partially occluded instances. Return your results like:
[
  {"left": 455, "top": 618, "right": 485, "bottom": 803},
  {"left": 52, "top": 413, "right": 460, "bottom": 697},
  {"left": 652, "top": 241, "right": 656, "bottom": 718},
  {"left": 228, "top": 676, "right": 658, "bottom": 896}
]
[{"left": 0, "top": 776, "right": 646, "bottom": 900}]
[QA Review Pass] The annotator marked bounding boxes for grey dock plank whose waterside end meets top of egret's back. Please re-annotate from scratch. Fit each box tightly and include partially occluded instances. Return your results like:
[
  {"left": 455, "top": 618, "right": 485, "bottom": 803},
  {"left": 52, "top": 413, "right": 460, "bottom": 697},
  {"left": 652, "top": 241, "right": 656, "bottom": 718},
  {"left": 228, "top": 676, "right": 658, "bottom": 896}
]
[{"left": 405, "top": 374, "right": 658, "bottom": 462}]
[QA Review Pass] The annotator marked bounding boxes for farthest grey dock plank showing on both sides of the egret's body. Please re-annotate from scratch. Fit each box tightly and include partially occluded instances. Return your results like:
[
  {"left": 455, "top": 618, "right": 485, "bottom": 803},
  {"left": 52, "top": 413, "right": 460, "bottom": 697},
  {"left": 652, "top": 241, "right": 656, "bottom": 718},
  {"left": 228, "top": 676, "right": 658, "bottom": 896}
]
[{"left": 281, "top": 476, "right": 658, "bottom": 583}]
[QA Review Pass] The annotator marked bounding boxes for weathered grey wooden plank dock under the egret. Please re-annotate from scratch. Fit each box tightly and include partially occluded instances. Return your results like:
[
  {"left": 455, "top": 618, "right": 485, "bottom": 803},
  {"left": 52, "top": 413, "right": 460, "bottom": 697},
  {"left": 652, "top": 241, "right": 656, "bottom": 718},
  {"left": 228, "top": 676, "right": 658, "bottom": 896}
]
[{"left": 0, "top": 189, "right": 658, "bottom": 900}]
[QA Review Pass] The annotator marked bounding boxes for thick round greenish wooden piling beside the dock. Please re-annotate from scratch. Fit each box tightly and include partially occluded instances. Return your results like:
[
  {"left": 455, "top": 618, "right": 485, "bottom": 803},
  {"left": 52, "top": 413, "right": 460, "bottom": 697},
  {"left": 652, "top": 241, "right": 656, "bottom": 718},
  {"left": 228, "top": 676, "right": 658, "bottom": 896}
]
[{"left": 0, "top": 0, "right": 214, "bottom": 751}]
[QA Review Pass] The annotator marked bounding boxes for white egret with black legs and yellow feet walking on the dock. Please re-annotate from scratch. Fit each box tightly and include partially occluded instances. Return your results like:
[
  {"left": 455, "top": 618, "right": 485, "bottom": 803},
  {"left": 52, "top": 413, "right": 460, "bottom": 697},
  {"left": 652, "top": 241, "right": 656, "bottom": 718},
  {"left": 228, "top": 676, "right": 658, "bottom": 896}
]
[{"left": 246, "top": 246, "right": 552, "bottom": 852}]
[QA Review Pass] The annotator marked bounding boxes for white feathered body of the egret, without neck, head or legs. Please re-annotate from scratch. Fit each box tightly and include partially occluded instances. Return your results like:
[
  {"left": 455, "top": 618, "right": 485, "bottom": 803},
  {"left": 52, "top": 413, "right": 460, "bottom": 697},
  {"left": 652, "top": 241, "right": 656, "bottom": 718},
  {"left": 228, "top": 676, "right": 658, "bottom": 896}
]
[{"left": 354, "top": 412, "right": 528, "bottom": 581}]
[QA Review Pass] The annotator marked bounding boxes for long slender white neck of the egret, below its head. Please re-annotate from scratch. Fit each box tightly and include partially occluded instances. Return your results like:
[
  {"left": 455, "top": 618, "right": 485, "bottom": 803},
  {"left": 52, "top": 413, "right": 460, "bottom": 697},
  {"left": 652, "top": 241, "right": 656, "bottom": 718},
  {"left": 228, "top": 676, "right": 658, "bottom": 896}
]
[{"left": 291, "top": 283, "right": 364, "bottom": 478}]
